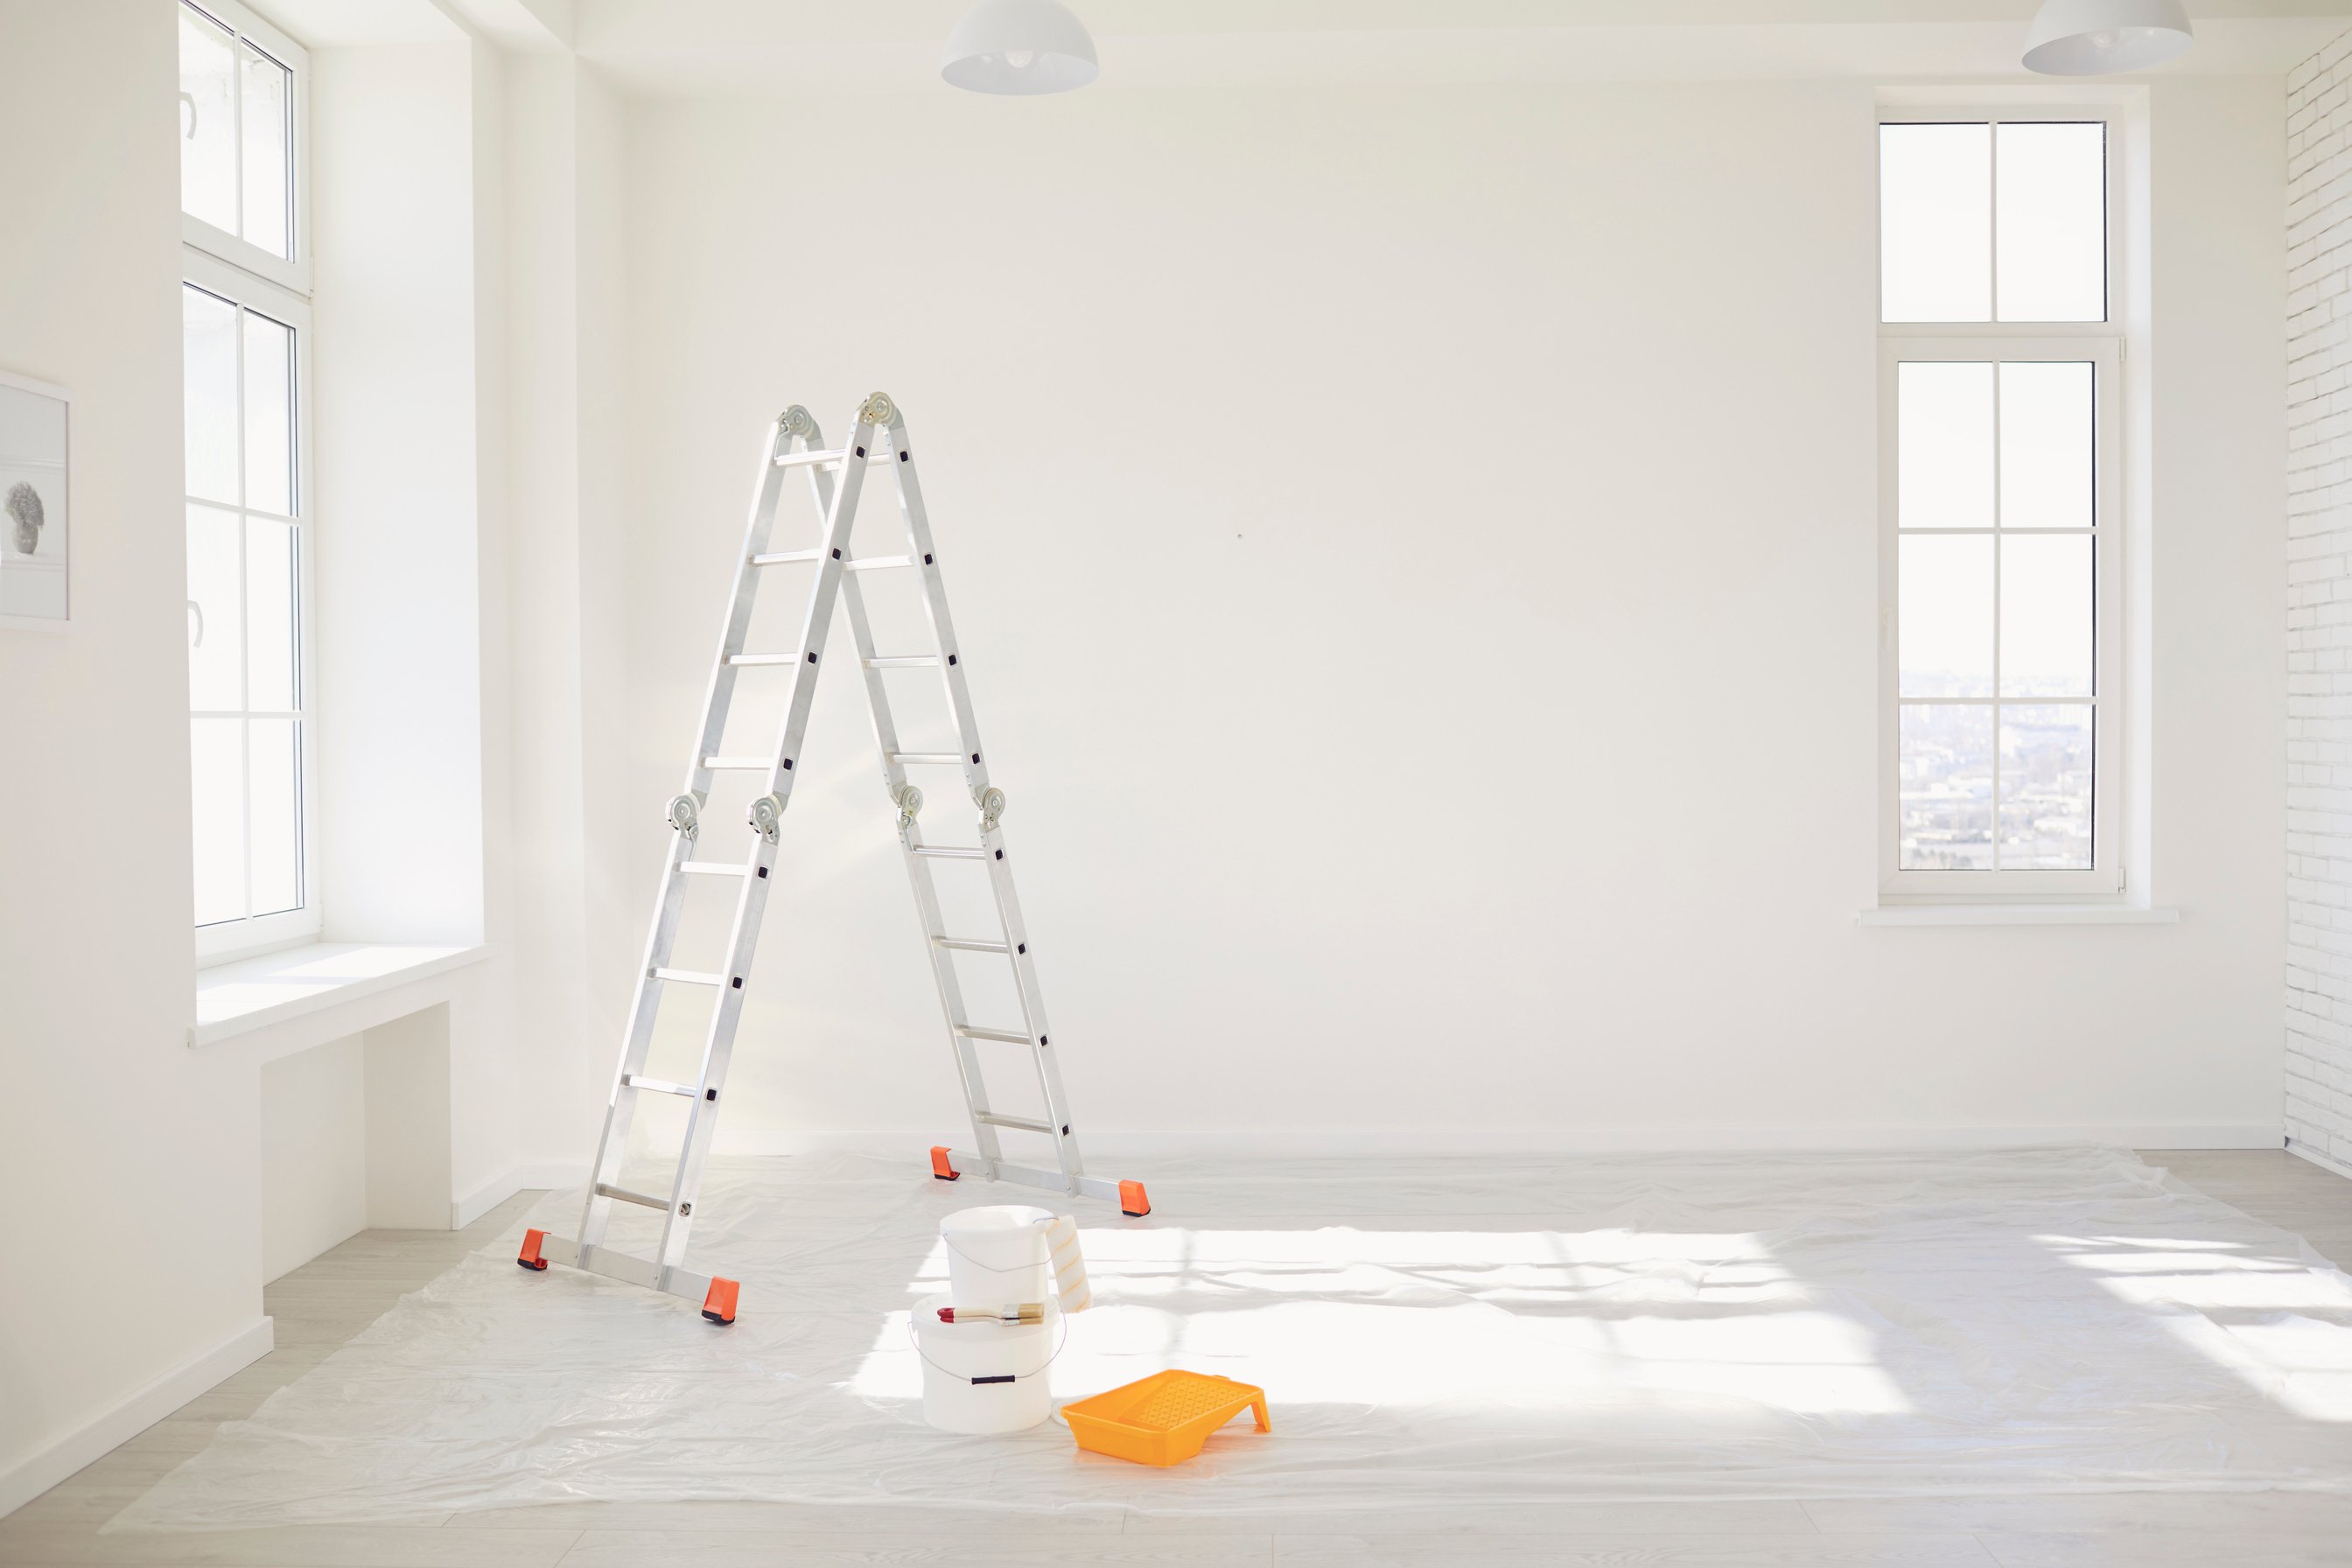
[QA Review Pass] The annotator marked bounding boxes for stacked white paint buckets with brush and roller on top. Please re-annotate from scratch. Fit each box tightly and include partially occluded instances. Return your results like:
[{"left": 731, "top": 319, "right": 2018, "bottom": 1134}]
[{"left": 915, "top": 1204, "right": 1087, "bottom": 1432}]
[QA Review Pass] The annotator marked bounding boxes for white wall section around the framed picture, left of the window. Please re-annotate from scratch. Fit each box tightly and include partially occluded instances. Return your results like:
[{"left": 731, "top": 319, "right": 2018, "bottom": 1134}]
[{"left": 0, "top": 0, "right": 268, "bottom": 1509}]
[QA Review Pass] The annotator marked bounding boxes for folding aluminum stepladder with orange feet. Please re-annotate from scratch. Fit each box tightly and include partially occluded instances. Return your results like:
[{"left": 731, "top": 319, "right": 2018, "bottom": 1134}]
[{"left": 517, "top": 393, "right": 1150, "bottom": 1324}]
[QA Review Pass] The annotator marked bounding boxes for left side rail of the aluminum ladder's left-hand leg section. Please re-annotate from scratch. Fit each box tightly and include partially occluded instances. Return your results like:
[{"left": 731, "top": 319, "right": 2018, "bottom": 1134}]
[{"left": 574, "top": 404, "right": 814, "bottom": 1267}]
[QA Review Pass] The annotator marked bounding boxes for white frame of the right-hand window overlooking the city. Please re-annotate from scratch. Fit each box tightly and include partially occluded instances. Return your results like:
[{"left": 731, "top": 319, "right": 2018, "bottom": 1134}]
[{"left": 1872, "top": 102, "right": 2131, "bottom": 905}]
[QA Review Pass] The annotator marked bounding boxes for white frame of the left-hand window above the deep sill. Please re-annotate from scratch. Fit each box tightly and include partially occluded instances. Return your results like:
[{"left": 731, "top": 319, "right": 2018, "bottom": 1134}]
[{"left": 181, "top": 0, "right": 325, "bottom": 964}]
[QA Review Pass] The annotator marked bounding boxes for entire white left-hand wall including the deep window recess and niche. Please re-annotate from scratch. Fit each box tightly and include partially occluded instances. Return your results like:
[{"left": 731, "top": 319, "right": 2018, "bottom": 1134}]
[{"left": 0, "top": 0, "right": 524, "bottom": 1512}]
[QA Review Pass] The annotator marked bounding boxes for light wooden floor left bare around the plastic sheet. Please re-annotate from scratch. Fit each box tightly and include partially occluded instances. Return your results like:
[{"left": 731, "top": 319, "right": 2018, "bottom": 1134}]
[{"left": 13, "top": 1152, "right": 2352, "bottom": 1568}]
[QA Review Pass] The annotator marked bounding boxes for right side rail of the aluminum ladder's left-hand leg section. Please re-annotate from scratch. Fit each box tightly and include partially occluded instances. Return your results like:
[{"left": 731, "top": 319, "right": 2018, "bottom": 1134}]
[{"left": 659, "top": 400, "right": 875, "bottom": 1267}]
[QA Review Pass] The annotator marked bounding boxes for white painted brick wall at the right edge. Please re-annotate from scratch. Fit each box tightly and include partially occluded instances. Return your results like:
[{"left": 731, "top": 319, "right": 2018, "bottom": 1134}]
[{"left": 2286, "top": 33, "right": 2352, "bottom": 1164}]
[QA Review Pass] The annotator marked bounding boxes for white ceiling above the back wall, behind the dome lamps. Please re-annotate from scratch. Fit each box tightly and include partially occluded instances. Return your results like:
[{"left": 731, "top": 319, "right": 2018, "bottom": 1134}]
[{"left": 261, "top": 0, "right": 2352, "bottom": 96}]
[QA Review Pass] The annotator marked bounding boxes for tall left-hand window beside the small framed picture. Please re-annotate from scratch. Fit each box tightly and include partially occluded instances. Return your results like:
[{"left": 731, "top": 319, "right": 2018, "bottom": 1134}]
[{"left": 178, "top": 3, "right": 320, "bottom": 956}]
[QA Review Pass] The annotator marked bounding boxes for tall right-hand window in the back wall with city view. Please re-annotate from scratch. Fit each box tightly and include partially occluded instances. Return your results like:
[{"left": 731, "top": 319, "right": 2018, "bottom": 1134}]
[{"left": 1880, "top": 113, "right": 2124, "bottom": 903}]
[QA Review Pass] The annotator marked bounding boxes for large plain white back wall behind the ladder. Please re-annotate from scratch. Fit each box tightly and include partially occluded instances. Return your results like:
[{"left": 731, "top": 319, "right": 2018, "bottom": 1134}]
[{"left": 602, "top": 78, "right": 2284, "bottom": 1147}]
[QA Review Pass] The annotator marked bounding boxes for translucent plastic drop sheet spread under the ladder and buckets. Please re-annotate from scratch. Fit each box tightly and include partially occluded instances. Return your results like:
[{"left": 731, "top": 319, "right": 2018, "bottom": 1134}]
[{"left": 108, "top": 1150, "right": 2352, "bottom": 1530}]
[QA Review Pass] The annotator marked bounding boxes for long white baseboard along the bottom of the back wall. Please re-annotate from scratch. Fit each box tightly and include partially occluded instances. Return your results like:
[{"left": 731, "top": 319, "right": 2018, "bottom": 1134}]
[{"left": 710, "top": 1122, "right": 2281, "bottom": 1161}]
